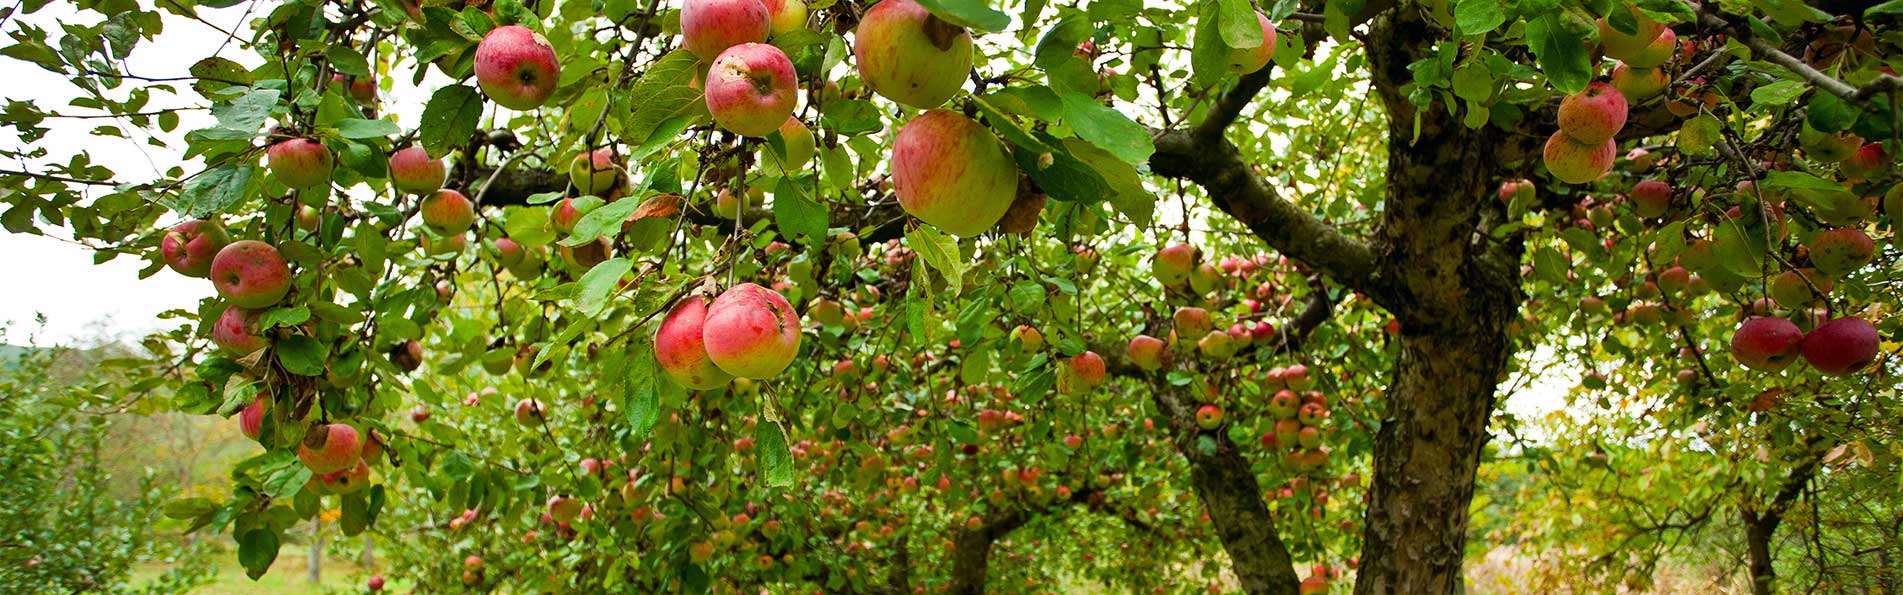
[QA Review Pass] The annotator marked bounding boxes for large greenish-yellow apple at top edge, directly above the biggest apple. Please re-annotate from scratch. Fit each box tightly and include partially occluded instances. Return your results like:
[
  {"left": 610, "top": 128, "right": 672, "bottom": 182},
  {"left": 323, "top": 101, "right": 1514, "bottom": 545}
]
[{"left": 853, "top": 0, "right": 972, "bottom": 108}]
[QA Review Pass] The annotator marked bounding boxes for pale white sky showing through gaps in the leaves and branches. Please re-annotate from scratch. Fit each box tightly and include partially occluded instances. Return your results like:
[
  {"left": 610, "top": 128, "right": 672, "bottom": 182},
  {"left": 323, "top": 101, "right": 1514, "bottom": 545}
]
[{"left": 0, "top": 2, "right": 1576, "bottom": 416}]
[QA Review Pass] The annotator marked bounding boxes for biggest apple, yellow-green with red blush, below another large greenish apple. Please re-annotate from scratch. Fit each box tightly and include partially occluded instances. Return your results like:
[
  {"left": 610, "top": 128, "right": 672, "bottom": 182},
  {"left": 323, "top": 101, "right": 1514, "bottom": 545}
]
[{"left": 873, "top": 110, "right": 1018, "bottom": 236}]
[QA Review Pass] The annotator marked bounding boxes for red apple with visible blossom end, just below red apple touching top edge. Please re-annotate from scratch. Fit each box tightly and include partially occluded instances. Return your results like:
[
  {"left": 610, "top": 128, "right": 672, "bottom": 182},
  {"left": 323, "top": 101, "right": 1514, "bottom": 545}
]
[{"left": 706, "top": 43, "right": 799, "bottom": 137}]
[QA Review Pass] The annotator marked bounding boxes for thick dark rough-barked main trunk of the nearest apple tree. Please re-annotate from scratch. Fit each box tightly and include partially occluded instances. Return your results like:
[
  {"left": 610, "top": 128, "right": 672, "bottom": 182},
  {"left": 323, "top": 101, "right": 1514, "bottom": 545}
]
[{"left": 1355, "top": 11, "right": 1524, "bottom": 593}]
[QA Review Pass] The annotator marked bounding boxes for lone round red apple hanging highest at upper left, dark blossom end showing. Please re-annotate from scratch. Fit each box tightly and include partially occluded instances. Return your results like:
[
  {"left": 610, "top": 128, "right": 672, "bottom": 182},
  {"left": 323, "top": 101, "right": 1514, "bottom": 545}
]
[{"left": 476, "top": 25, "right": 559, "bottom": 112}]
